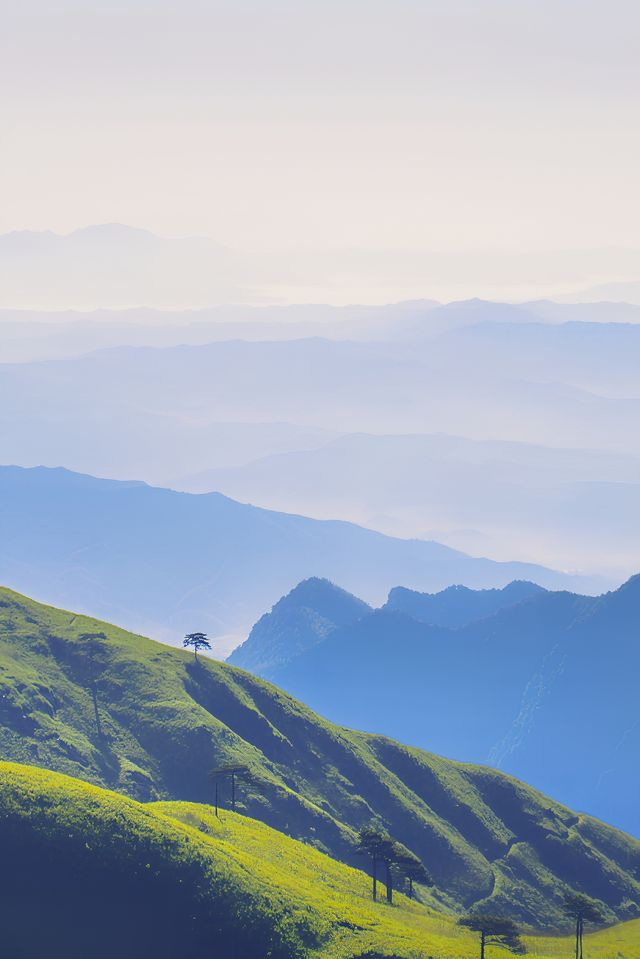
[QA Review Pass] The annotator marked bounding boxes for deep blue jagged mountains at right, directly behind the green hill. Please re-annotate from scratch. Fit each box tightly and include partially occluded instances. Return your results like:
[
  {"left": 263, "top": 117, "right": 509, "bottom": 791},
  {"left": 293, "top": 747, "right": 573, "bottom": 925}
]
[{"left": 229, "top": 576, "right": 640, "bottom": 835}]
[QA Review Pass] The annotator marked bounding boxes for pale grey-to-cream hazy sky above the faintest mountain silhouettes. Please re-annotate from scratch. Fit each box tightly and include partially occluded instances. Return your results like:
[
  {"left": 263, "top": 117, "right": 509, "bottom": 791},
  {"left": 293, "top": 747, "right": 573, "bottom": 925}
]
[{"left": 0, "top": 0, "right": 640, "bottom": 264}]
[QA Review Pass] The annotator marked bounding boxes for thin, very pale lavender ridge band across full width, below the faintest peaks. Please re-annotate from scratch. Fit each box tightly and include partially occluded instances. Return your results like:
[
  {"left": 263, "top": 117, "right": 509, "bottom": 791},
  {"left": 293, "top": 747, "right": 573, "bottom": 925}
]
[{"left": 5, "top": 299, "right": 640, "bottom": 366}]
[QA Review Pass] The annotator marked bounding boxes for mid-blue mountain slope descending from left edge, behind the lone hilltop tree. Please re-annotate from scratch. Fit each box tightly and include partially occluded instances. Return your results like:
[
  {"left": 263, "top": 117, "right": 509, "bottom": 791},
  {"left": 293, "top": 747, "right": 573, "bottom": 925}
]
[{"left": 0, "top": 467, "right": 597, "bottom": 655}]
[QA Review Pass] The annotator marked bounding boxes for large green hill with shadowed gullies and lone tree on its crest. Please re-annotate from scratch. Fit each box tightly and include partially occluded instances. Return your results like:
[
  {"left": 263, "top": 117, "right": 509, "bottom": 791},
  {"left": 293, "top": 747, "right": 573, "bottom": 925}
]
[{"left": 0, "top": 590, "right": 640, "bottom": 927}]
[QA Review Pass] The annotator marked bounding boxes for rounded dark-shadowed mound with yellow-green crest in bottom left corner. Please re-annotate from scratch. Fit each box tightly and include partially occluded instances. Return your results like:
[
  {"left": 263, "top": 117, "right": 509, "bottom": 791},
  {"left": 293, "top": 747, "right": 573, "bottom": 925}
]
[{"left": 0, "top": 763, "right": 312, "bottom": 959}]
